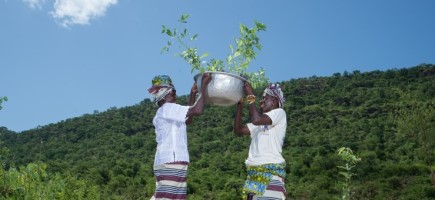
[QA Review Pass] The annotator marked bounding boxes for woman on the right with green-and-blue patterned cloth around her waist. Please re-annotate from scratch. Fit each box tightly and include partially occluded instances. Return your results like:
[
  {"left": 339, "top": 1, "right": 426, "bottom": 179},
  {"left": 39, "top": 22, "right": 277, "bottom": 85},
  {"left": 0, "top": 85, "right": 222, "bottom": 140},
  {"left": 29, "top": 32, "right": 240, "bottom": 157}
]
[{"left": 234, "top": 82, "right": 287, "bottom": 199}]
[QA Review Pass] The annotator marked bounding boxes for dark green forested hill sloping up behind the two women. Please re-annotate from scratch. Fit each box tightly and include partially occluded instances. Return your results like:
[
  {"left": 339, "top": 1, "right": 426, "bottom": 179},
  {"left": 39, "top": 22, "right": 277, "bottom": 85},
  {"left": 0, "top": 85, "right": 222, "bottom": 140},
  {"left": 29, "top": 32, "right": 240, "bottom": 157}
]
[{"left": 0, "top": 64, "right": 435, "bottom": 200}]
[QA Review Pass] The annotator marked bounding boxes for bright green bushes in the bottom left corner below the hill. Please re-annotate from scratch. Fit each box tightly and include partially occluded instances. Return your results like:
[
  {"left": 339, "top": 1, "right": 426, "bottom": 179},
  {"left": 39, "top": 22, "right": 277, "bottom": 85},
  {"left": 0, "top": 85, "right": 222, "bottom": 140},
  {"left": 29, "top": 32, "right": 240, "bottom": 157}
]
[{"left": 0, "top": 147, "right": 100, "bottom": 200}]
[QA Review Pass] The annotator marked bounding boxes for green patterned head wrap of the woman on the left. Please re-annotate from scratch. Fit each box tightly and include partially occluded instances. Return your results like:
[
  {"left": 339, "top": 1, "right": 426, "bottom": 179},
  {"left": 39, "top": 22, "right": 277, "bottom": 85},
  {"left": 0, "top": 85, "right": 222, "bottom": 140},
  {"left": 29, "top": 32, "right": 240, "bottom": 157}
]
[{"left": 148, "top": 75, "right": 175, "bottom": 104}]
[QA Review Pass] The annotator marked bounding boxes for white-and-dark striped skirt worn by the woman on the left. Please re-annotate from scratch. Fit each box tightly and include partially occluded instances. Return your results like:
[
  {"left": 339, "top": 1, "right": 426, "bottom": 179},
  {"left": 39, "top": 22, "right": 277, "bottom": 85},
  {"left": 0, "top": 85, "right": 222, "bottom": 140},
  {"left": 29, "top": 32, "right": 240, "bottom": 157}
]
[{"left": 151, "top": 162, "right": 188, "bottom": 199}]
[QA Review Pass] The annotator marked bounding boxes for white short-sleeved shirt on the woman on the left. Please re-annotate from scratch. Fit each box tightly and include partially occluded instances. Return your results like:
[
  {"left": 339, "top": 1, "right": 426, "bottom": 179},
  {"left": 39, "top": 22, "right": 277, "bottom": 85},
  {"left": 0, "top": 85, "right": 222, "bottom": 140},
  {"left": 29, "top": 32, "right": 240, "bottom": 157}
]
[{"left": 153, "top": 103, "right": 189, "bottom": 166}]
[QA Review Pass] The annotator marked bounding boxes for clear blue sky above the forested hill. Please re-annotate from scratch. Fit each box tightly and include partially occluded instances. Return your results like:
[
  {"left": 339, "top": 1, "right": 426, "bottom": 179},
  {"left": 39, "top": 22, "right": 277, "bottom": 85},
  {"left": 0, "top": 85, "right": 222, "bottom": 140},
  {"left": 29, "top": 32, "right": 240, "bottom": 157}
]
[{"left": 0, "top": 0, "right": 435, "bottom": 132}]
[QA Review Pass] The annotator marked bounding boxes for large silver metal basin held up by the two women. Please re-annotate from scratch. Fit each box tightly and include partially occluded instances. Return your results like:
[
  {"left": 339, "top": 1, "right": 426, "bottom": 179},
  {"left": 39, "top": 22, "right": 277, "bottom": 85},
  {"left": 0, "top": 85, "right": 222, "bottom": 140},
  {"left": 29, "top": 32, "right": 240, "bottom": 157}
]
[{"left": 194, "top": 71, "right": 246, "bottom": 106}]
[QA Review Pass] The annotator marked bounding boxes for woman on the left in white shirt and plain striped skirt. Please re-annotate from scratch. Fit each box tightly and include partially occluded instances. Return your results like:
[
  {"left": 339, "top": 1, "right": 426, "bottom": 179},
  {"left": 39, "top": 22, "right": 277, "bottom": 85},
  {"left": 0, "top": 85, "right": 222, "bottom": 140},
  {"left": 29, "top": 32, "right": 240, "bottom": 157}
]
[{"left": 148, "top": 73, "right": 211, "bottom": 199}]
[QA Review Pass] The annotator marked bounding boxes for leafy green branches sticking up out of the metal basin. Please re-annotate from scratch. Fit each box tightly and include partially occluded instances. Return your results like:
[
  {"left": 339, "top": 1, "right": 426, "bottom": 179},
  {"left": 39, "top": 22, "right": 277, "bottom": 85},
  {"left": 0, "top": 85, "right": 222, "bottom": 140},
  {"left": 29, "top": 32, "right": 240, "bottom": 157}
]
[{"left": 162, "top": 14, "right": 268, "bottom": 88}]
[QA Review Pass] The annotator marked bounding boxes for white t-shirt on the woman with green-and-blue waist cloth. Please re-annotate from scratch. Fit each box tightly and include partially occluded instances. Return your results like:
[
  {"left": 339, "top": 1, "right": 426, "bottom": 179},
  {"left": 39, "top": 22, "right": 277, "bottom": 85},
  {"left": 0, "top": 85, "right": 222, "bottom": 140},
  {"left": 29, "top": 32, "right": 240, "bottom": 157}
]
[{"left": 245, "top": 108, "right": 287, "bottom": 166}]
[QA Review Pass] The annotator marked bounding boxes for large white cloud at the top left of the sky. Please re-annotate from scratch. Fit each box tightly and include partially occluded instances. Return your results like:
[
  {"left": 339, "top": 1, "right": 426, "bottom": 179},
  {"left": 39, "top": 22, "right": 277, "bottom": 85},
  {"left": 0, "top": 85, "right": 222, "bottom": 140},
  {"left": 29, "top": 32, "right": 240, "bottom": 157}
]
[{"left": 50, "top": 0, "right": 118, "bottom": 27}]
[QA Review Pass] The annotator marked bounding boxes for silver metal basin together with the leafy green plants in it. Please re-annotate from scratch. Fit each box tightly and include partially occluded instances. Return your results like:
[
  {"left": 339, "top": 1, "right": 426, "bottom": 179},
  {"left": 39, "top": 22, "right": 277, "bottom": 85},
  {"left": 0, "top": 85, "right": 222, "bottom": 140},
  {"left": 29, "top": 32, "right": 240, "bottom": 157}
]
[{"left": 162, "top": 14, "right": 268, "bottom": 106}]
